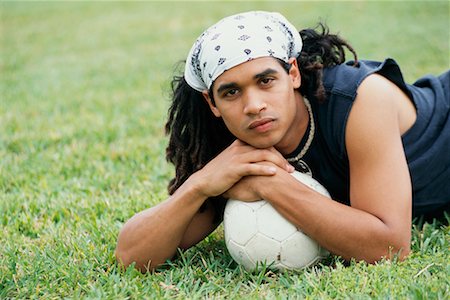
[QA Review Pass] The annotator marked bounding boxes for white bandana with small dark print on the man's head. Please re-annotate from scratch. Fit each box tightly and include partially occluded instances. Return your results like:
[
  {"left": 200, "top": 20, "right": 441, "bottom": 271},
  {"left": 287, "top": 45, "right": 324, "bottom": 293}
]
[{"left": 184, "top": 11, "right": 302, "bottom": 92}]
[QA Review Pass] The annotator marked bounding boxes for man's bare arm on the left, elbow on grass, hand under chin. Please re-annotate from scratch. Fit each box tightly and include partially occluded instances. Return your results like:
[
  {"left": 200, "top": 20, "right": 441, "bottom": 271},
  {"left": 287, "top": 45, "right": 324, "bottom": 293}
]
[{"left": 116, "top": 141, "right": 289, "bottom": 272}]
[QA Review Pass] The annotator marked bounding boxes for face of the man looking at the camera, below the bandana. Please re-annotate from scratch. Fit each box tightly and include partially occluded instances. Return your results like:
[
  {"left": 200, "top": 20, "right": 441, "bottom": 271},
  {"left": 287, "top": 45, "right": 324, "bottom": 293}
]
[{"left": 203, "top": 57, "right": 308, "bottom": 154}]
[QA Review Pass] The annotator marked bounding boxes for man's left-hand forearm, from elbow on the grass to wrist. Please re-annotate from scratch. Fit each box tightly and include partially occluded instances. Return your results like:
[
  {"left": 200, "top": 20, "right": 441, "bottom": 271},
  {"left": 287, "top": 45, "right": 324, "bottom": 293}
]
[{"left": 116, "top": 181, "right": 208, "bottom": 271}]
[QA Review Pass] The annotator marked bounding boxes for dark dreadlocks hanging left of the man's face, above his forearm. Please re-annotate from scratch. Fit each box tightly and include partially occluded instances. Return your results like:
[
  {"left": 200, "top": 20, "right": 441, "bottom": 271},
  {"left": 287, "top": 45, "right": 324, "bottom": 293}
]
[{"left": 165, "top": 76, "right": 234, "bottom": 194}]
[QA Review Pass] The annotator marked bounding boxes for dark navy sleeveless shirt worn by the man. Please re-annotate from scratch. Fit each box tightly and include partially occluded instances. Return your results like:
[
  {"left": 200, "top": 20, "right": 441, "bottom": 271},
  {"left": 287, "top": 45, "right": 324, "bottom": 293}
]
[{"left": 290, "top": 59, "right": 450, "bottom": 217}]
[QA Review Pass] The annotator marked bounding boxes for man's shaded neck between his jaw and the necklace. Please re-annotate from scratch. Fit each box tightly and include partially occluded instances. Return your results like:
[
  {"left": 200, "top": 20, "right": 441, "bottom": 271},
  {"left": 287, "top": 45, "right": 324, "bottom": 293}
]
[{"left": 276, "top": 92, "right": 309, "bottom": 155}]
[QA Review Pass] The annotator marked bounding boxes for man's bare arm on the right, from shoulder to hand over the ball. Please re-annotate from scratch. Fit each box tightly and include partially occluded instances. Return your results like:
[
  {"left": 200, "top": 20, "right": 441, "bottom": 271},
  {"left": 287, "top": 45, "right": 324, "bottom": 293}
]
[{"left": 231, "top": 75, "right": 412, "bottom": 262}]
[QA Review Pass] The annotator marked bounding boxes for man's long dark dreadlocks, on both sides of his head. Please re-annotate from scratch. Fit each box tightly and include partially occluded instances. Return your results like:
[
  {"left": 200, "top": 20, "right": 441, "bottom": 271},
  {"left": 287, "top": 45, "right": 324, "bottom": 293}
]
[{"left": 165, "top": 23, "right": 358, "bottom": 216}]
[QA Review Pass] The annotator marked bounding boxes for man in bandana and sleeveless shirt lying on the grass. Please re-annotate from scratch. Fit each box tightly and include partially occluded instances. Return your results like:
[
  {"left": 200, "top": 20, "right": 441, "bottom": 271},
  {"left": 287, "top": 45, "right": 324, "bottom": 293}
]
[{"left": 116, "top": 12, "right": 450, "bottom": 271}]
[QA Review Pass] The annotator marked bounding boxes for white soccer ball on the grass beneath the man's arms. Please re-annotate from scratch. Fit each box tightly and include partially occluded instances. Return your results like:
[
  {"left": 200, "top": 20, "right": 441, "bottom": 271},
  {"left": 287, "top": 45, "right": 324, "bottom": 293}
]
[{"left": 224, "top": 171, "right": 330, "bottom": 271}]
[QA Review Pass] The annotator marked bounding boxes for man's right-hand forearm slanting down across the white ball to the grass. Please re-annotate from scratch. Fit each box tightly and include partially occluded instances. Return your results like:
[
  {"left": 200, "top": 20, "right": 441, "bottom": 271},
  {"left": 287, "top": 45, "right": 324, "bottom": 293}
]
[{"left": 263, "top": 176, "right": 410, "bottom": 262}]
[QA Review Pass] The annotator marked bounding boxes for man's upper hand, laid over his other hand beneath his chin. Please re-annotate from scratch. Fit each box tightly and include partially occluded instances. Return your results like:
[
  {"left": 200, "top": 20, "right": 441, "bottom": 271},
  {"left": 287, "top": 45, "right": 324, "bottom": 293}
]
[{"left": 191, "top": 140, "right": 294, "bottom": 197}]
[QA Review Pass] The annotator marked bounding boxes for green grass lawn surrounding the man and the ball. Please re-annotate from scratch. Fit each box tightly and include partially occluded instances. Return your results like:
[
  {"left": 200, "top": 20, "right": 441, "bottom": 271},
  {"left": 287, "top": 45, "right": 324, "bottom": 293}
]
[{"left": 0, "top": 1, "right": 450, "bottom": 299}]
